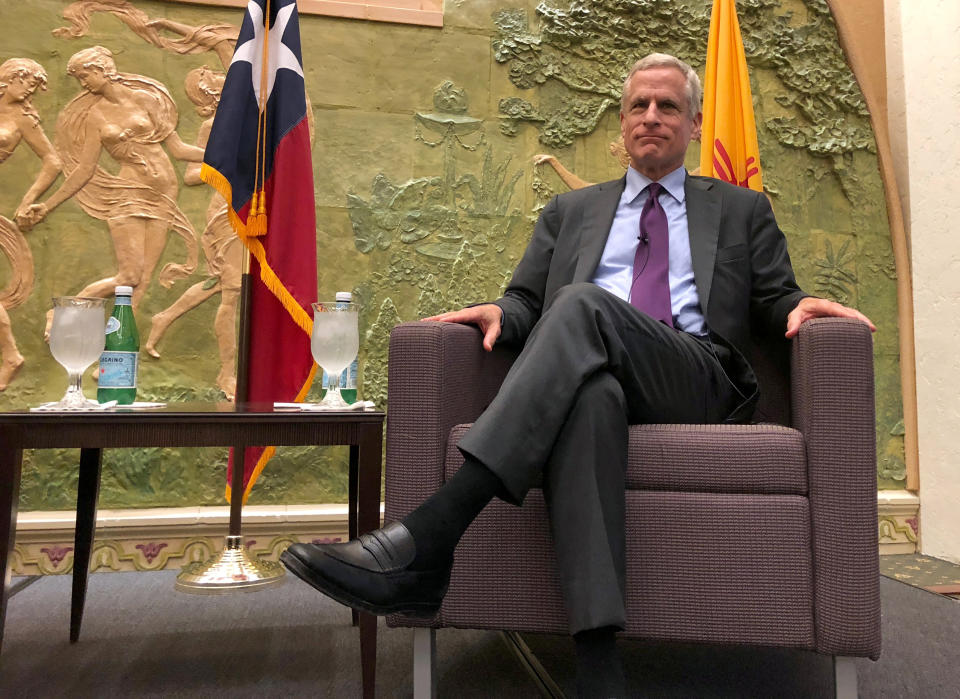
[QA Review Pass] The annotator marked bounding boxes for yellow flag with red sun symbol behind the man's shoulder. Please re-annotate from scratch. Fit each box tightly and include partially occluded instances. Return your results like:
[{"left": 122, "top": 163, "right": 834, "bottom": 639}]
[{"left": 700, "top": 0, "right": 763, "bottom": 192}]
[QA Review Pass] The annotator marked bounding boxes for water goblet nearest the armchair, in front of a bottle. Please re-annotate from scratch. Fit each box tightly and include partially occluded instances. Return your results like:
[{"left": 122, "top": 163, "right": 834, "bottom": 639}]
[{"left": 310, "top": 301, "right": 360, "bottom": 410}]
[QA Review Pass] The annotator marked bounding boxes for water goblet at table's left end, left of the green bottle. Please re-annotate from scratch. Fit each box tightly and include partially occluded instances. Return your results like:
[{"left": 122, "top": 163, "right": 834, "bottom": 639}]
[{"left": 50, "top": 296, "right": 106, "bottom": 410}]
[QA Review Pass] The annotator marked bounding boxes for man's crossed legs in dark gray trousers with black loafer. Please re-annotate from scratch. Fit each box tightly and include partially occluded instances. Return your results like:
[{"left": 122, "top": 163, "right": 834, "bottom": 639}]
[{"left": 281, "top": 284, "right": 736, "bottom": 696}]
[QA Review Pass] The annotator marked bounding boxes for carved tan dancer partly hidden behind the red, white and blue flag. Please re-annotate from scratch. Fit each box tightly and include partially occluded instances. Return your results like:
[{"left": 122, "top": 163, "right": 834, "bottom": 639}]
[{"left": 144, "top": 66, "right": 243, "bottom": 400}]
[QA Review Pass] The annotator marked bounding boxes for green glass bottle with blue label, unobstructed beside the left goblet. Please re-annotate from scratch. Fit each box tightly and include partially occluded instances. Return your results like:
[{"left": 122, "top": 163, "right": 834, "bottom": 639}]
[{"left": 97, "top": 286, "right": 140, "bottom": 405}]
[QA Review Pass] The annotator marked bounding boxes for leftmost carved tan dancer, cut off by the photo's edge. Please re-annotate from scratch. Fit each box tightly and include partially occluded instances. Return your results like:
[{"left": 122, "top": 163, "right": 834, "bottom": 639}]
[{"left": 0, "top": 58, "right": 60, "bottom": 391}]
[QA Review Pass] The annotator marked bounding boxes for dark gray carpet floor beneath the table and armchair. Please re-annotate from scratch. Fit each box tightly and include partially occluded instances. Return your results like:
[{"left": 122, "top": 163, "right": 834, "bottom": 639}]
[{"left": 0, "top": 571, "right": 960, "bottom": 699}]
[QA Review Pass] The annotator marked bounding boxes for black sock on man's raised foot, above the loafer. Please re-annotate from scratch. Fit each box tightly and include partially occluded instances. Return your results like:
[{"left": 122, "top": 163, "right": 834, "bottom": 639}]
[{"left": 403, "top": 458, "right": 502, "bottom": 570}]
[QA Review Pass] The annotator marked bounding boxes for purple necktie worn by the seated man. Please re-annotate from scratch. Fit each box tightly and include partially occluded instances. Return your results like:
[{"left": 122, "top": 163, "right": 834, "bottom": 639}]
[{"left": 630, "top": 182, "right": 673, "bottom": 327}]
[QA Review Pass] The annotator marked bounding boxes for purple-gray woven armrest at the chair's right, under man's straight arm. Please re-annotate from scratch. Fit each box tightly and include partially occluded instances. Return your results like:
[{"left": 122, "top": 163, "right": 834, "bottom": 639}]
[{"left": 791, "top": 318, "right": 880, "bottom": 658}]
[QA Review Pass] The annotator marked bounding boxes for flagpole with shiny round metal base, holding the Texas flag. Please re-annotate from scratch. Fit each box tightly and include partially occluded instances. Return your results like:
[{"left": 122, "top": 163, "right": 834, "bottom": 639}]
[{"left": 174, "top": 246, "right": 286, "bottom": 594}]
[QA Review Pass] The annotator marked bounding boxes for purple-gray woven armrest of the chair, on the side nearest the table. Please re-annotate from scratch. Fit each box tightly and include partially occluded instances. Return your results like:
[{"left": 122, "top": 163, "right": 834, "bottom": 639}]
[{"left": 384, "top": 321, "right": 516, "bottom": 521}]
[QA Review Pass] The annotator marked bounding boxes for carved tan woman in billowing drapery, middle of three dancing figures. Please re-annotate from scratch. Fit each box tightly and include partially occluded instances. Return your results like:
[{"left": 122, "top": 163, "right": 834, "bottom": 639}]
[{"left": 21, "top": 46, "right": 203, "bottom": 332}]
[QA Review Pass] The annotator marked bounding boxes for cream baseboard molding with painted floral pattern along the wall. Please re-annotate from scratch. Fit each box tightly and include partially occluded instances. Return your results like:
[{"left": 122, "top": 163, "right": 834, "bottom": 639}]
[{"left": 10, "top": 490, "right": 920, "bottom": 575}]
